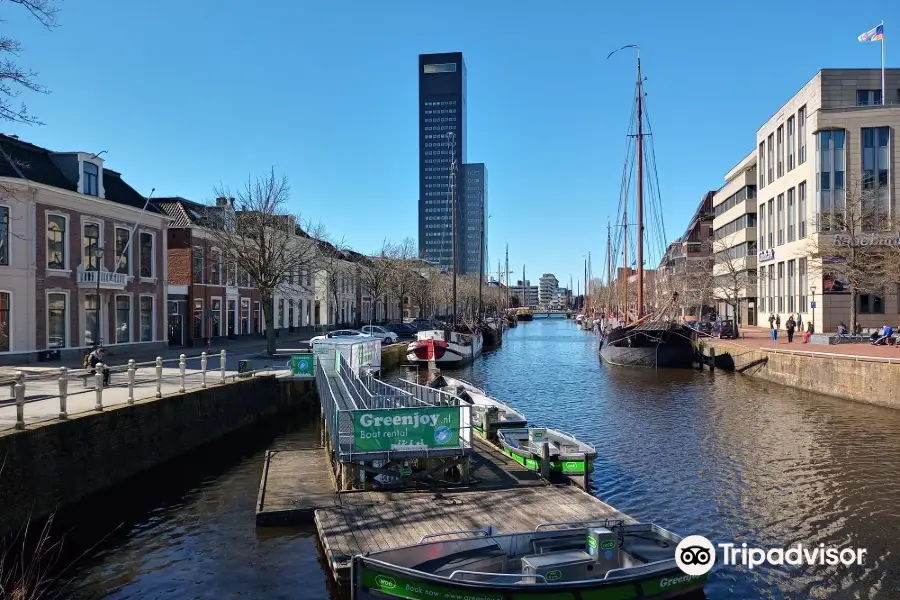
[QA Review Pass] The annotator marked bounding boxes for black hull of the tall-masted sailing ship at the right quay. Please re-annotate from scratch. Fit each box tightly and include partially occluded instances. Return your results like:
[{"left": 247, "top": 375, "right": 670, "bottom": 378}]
[{"left": 600, "top": 327, "right": 698, "bottom": 369}]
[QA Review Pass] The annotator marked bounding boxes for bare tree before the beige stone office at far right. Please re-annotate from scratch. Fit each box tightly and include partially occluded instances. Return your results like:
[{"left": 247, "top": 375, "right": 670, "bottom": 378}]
[{"left": 809, "top": 177, "right": 898, "bottom": 331}]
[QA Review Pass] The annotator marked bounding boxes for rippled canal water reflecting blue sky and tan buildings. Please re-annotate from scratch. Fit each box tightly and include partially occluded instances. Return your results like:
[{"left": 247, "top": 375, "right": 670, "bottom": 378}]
[{"left": 54, "top": 319, "right": 900, "bottom": 600}]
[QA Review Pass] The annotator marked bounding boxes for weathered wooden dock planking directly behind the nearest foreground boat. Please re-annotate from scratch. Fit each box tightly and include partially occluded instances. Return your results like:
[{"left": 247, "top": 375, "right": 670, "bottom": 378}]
[{"left": 315, "top": 485, "right": 634, "bottom": 583}]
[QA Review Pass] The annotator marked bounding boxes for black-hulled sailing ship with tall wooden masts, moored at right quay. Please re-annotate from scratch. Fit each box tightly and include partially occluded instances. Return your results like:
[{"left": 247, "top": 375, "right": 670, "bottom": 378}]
[{"left": 600, "top": 45, "right": 698, "bottom": 369}]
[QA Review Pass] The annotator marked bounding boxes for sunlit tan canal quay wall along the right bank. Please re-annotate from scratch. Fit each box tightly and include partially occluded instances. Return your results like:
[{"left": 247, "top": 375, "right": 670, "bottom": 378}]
[{"left": 704, "top": 340, "right": 900, "bottom": 409}]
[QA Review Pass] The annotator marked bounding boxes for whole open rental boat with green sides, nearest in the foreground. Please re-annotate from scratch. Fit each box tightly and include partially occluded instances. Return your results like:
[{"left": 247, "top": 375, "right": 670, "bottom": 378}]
[{"left": 352, "top": 520, "right": 707, "bottom": 600}]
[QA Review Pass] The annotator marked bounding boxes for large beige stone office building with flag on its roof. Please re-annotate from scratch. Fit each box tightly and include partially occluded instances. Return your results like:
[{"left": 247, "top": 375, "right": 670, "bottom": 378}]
[{"left": 756, "top": 69, "right": 900, "bottom": 332}]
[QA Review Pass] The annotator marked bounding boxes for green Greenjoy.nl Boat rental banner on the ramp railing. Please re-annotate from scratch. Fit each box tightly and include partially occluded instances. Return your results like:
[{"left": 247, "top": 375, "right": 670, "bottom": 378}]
[{"left": 351, "top": 406, "right": 460, "bottom": 452}]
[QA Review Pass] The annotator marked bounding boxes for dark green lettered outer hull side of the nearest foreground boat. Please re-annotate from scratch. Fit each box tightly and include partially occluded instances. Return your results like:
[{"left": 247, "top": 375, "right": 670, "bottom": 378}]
[{"left": 351, "top": 555, "right": 708, "bottom": 600}]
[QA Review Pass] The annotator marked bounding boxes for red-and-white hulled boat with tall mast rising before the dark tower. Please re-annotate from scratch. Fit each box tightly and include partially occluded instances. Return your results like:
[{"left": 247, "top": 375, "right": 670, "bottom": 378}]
[{"left": 406, "top": 132, "right": 484, "bottom": 368}]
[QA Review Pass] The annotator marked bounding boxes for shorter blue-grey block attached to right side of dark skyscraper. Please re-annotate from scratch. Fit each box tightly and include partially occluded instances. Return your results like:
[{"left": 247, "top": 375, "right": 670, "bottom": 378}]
[{"left": 458, "top": 163, "right": 490, "bottom": 275}]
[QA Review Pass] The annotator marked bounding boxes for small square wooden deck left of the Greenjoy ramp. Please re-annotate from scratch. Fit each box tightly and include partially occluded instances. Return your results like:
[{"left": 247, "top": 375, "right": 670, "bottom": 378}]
[{"left": 256, "top": 448, "right": 339, "bottom": 525}]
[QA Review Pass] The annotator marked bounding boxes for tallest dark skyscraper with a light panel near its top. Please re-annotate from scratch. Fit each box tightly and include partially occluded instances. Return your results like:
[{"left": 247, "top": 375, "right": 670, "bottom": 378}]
[{"left": 419, "top": 52, "right": 466, "bottom": 270}]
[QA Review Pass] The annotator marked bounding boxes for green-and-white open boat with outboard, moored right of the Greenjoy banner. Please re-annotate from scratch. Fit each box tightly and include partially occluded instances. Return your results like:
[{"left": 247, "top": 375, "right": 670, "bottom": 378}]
[{"left": 497, "top": 427, "right": 597, "bottom": 477}]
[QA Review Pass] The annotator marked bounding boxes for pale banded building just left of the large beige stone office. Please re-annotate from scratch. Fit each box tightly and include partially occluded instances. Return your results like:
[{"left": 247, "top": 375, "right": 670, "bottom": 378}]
[{"left": 712, "top": 151, "right": 758, "bottom": 325}]
